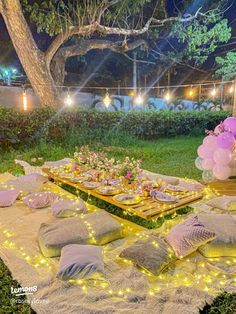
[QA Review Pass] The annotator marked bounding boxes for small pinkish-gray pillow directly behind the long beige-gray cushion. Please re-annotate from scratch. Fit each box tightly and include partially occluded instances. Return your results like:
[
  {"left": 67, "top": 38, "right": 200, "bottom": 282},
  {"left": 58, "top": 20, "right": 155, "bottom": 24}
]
[{"left": 52, "top": 199, "right": 88, "bottom": 218}]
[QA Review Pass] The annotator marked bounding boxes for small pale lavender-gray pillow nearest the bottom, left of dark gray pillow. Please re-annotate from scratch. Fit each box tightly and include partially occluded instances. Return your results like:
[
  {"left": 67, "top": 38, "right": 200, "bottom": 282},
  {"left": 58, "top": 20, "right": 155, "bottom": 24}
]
[{"left": 57, "top": 244, "right": 104, "bottom": 280}]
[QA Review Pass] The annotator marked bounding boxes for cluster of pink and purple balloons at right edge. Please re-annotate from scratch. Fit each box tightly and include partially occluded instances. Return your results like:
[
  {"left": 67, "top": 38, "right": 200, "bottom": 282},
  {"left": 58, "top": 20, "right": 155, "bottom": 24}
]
[{"left": 195, "top": 117, "right": 236, "bottom": 182}]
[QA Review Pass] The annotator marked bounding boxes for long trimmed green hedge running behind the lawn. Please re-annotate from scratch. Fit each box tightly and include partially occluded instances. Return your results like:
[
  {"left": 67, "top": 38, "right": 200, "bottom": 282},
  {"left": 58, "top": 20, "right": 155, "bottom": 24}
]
[{"left": 0, "top": 107, "right": 229, "bottom": 145}]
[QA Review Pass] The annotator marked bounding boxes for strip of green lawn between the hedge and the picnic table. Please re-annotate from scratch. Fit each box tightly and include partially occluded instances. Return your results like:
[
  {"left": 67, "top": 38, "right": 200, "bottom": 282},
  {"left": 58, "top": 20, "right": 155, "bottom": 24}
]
[{"left": 0, "top": 134, "right": 202, "bottom": 179}]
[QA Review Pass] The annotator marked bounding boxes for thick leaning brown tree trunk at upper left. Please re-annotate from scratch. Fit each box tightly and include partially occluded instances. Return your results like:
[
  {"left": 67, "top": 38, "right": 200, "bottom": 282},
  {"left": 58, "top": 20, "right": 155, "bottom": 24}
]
[{"left": 0, "top": 0, "right": 59, "bottom": 106}]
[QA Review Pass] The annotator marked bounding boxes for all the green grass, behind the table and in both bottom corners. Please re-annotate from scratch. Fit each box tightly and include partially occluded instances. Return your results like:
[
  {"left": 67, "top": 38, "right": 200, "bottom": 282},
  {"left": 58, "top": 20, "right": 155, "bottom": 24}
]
[{"left": 0, "top": 132, "right": 236, "bottom": 314}]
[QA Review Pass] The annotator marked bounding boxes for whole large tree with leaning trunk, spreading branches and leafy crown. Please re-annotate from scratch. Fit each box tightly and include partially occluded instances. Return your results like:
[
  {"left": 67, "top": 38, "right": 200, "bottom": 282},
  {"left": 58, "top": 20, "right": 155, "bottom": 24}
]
[{"left": 0, "top": 0, "right": 231, "bottom": 103}]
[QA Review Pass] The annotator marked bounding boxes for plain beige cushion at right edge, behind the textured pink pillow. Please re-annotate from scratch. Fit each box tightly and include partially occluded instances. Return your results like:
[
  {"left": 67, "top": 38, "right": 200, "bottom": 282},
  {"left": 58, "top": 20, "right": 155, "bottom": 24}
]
[{"left": 198, "top": 213, "right": 236, "bottom": 257}]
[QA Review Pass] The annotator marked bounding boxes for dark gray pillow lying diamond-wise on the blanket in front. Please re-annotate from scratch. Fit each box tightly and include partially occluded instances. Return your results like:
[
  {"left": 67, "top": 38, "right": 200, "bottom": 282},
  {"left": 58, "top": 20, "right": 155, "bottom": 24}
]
[{"left": 120, "top": 235, "right": 176, "bottom": 275}]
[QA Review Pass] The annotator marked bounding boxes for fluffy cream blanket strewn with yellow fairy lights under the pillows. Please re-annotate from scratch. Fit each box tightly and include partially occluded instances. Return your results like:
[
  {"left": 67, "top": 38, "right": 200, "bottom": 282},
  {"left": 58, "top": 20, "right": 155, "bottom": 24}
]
[{"left": 0, "top": 175, "right": 236, "bottom": 314}]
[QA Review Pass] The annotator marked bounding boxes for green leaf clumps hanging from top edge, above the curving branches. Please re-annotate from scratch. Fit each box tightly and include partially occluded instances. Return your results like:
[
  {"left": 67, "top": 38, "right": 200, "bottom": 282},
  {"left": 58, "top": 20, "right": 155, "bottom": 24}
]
[{"left": 21, "top": 0, "right": 151, "bottom": 36}]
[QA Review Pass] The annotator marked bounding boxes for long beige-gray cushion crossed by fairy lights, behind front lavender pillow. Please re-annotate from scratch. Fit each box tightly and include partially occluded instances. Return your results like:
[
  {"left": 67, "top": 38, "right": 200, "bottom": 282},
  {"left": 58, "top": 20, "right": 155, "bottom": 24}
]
[{"left": 38, "top": 210, "right": 123, "bottom": 257}]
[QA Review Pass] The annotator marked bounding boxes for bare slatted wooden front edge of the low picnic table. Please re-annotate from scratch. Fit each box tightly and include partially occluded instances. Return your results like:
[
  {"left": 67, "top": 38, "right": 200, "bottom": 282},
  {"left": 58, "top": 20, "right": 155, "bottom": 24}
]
[{"left": 43, "top": 168, "right": 203, "bottom": 220}]
